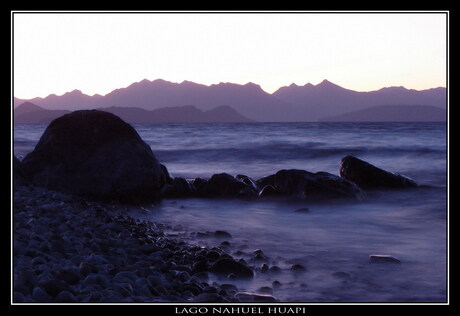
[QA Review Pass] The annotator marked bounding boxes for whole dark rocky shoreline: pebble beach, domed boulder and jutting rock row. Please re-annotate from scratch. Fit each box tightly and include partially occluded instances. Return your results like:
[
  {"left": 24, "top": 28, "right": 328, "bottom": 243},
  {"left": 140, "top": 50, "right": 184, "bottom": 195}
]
[{"left": 12, "top": 110, "right": 417, "bottom": 303}]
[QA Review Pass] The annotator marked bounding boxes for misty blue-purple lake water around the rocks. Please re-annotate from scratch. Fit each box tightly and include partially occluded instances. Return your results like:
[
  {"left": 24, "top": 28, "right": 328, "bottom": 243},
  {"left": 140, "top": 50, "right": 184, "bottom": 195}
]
[{"left": 14, "top": 123, "right": 448, "bottom": 302}]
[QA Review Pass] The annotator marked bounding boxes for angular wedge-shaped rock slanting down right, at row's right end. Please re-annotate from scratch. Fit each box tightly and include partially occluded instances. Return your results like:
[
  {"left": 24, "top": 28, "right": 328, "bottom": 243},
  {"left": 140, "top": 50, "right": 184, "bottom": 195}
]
[{"left": 339, "top": 156, "right": 417, "bottom": 190}]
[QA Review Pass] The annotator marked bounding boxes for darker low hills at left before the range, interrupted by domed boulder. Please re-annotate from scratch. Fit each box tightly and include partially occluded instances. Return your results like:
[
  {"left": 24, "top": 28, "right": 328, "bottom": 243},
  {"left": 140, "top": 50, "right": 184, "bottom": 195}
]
[{"left": 13, "top": 102, "right": 252, "bottom": 124}]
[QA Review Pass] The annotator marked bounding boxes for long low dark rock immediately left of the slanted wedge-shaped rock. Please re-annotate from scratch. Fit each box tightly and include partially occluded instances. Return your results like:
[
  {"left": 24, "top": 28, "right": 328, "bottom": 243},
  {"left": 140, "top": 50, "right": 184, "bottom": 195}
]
[{"left": 274, "top": 169, "right": 363, "bottom": 200}]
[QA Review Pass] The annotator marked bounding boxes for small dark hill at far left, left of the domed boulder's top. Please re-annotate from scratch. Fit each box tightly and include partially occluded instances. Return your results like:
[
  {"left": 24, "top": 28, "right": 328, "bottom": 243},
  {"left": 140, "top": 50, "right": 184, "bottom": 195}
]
[{"left": 13, "top": 102, "right": 70, "bottom": 124}]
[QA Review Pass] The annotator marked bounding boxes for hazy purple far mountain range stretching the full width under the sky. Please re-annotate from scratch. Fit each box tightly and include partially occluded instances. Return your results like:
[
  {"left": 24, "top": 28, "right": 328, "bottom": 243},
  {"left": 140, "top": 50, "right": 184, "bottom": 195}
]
[{"left": 14, "top": 79, "right": 447, "bottom": 122}]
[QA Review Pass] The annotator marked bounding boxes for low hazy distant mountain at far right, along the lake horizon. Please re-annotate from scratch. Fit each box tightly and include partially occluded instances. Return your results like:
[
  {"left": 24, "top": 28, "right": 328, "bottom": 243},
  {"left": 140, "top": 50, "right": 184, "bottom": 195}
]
[{"left": 319, "top": 105, "right": 447, "bottom": 122}]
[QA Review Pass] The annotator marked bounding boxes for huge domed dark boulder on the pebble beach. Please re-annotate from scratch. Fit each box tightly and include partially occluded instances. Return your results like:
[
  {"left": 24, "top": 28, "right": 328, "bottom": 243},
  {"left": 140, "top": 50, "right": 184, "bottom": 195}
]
[{"left": 22, "top": 110, "right": 166, "bottom": 203}]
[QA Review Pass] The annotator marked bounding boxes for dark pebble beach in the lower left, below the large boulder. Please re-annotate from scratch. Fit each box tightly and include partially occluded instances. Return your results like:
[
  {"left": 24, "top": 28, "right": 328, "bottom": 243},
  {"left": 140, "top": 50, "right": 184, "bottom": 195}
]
[{"left": 13, "top": 186, "right": 284, "bottom": 303}]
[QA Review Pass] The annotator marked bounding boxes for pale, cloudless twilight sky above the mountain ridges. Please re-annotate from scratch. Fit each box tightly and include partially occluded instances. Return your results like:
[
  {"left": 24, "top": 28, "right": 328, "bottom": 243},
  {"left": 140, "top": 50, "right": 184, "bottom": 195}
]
[{"left": 12, "top": 11, "right": 448, "bottom": 99}]
